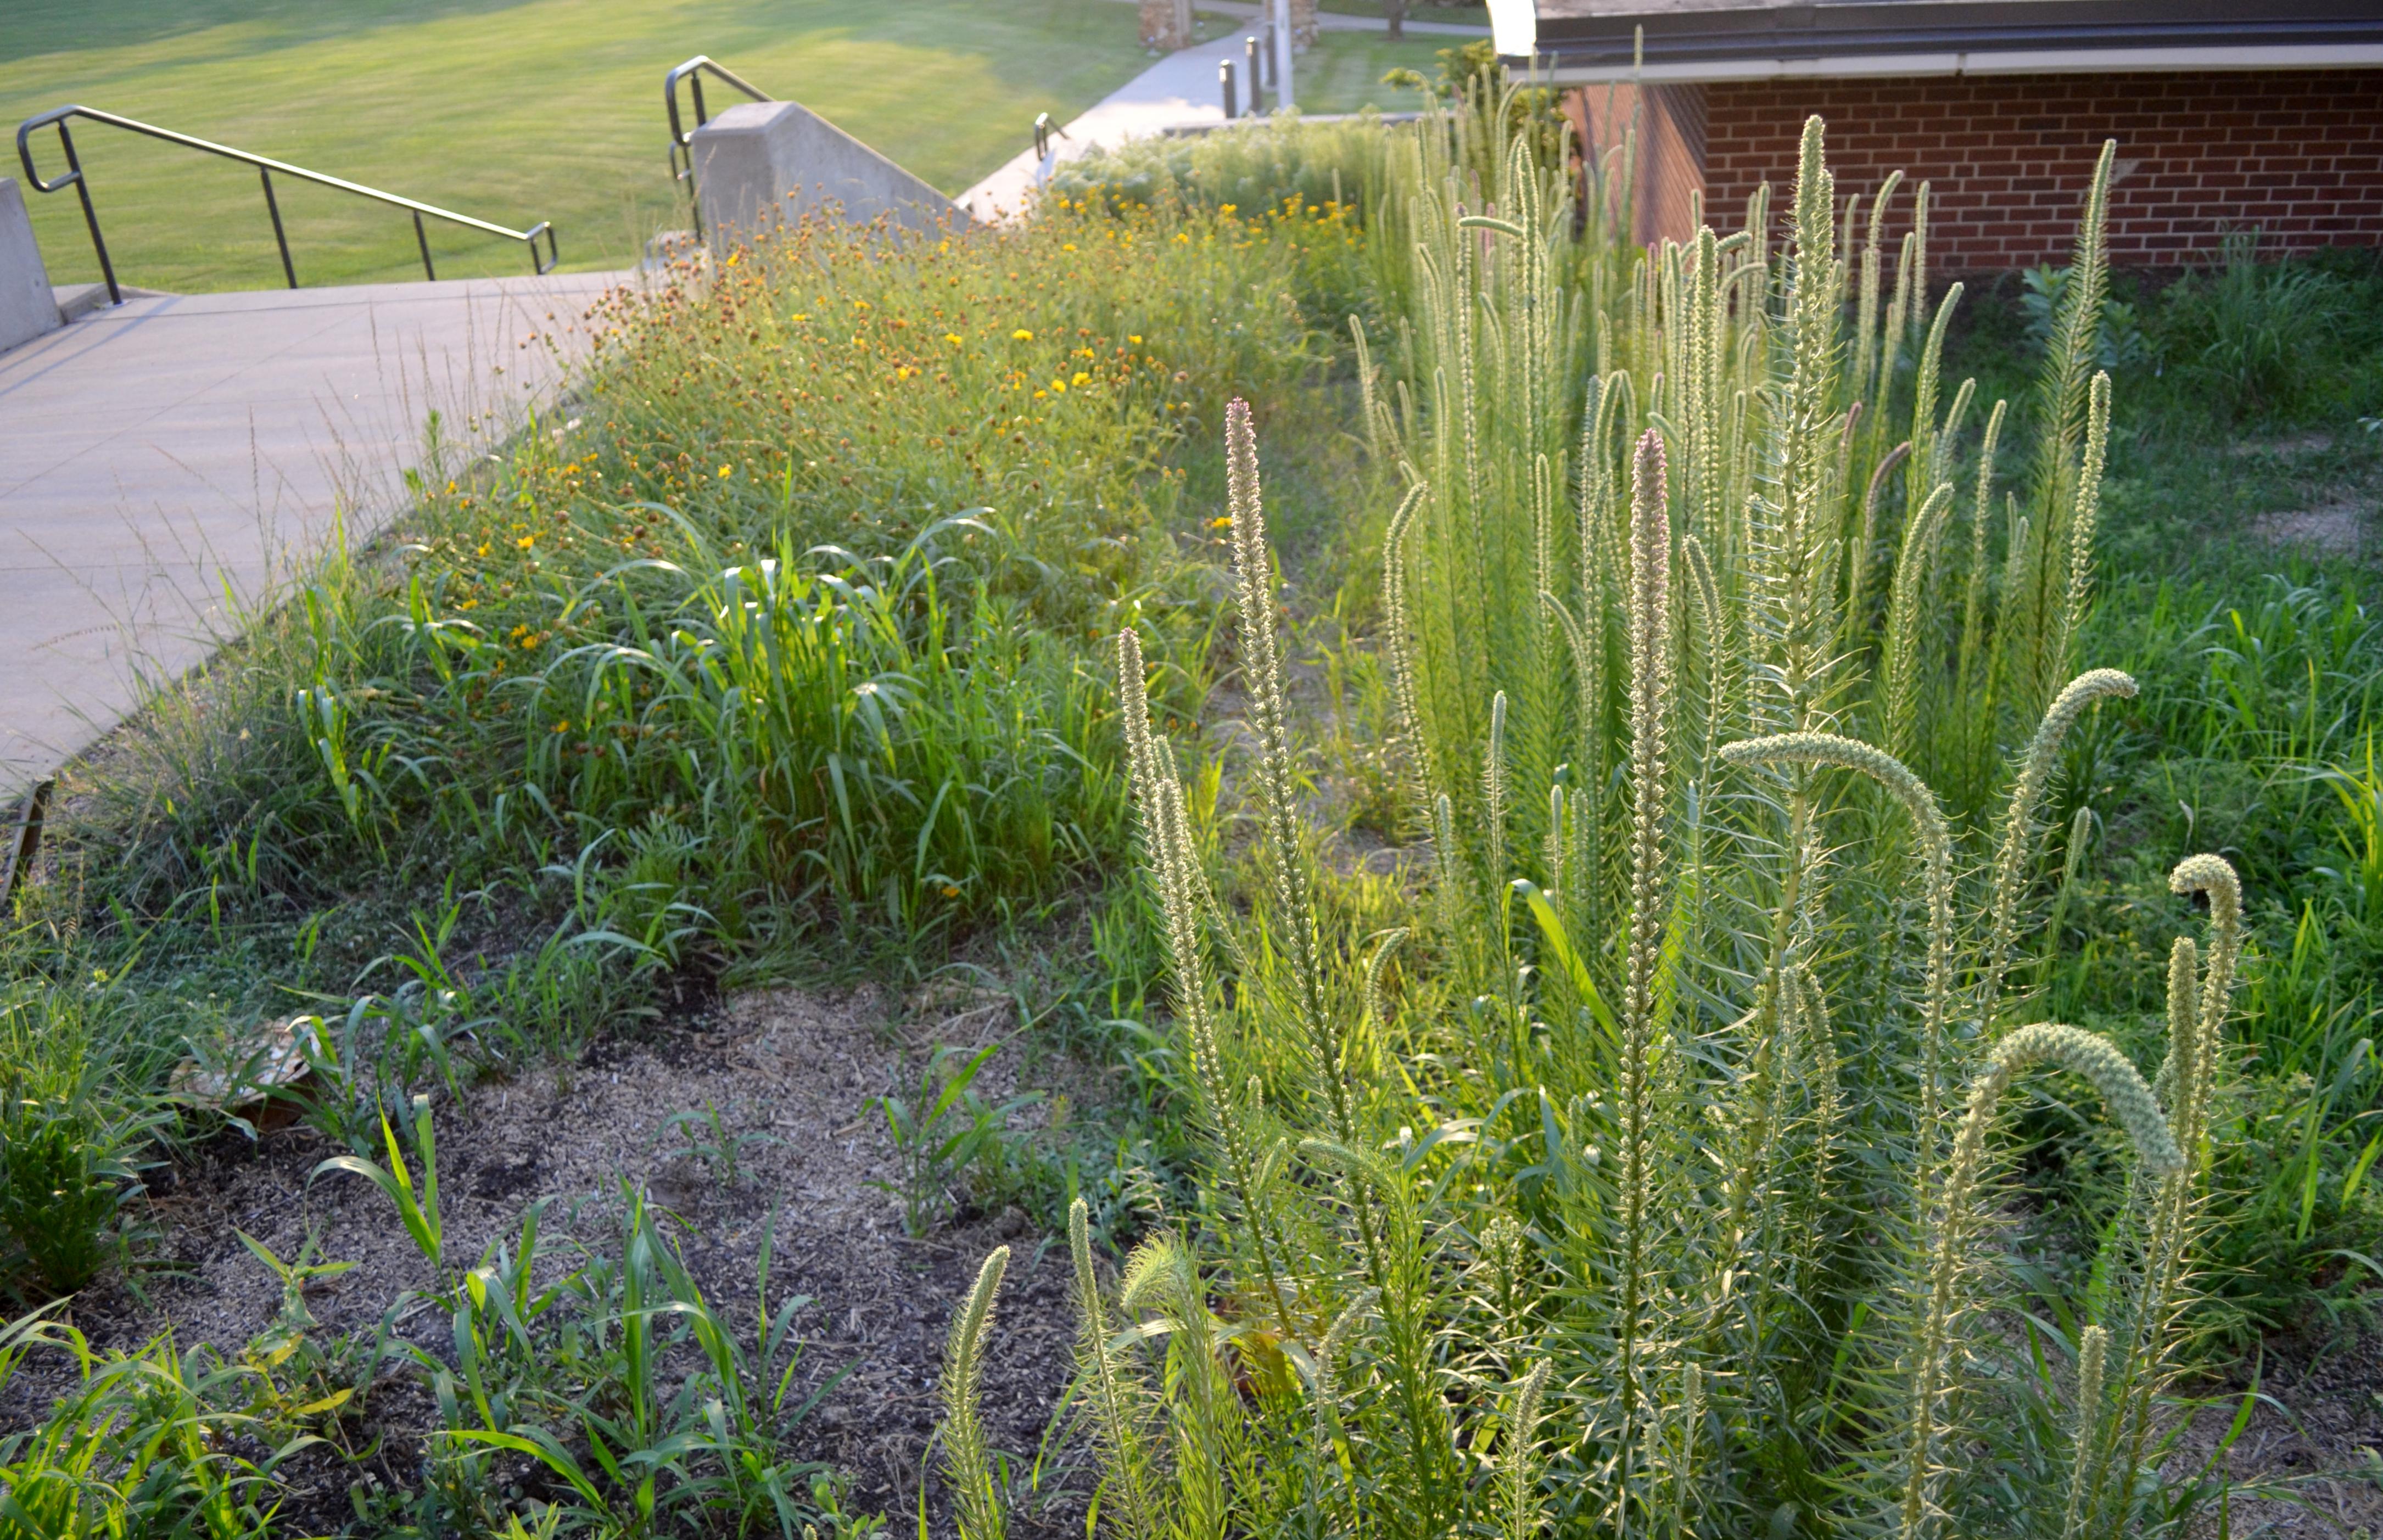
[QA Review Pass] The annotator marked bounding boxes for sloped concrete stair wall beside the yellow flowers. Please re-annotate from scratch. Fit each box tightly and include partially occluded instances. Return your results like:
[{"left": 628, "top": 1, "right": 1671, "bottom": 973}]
[{"left": 693, "top": 103, "right": 970, "bottom": 250}]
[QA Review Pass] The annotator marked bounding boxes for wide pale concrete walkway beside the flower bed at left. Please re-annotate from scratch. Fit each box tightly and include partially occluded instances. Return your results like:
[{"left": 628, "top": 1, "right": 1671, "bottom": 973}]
[{"left": 0, "top": 272, "right": 631, "bottom": 796}]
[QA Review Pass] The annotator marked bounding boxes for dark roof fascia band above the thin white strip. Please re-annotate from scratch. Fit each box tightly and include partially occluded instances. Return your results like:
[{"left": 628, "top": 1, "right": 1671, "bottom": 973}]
[{"left": 1501, "top": 0, "right": 2383, "bottom": 74}]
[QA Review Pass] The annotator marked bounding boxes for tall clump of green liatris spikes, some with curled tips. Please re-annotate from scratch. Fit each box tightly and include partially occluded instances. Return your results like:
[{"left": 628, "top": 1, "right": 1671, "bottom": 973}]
[{"left": 920, "top": 93, "right": 2240, "bottom": 1540}]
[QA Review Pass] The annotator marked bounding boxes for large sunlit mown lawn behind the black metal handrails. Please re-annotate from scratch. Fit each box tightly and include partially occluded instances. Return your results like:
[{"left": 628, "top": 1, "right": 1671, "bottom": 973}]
[{"left": 0, "top": 0, "right": 1153, "bottom": 291}]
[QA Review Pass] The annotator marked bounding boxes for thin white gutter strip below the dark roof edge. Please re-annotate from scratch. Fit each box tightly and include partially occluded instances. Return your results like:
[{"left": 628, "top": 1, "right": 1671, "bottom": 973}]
[{"left": 1525, "top": 42, "right": 2383, "bottom": 86}]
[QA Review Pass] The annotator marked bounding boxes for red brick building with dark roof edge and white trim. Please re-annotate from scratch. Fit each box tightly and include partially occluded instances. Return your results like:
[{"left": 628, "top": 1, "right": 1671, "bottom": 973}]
[{"left": 1492, "top": 0, "right": 2383, "bottom": 274}]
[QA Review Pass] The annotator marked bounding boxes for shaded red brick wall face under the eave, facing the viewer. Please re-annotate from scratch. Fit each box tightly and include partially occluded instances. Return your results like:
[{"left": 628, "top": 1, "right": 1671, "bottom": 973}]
[{"left": 1639, "top": 69, "right": 2383, "bottom": 274}]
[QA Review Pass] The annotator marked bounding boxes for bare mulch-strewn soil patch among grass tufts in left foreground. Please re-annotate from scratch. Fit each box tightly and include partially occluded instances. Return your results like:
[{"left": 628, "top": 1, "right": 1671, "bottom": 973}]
[{"left": 0, "top": 987, "right": 1082, "bottom": 1535}]
